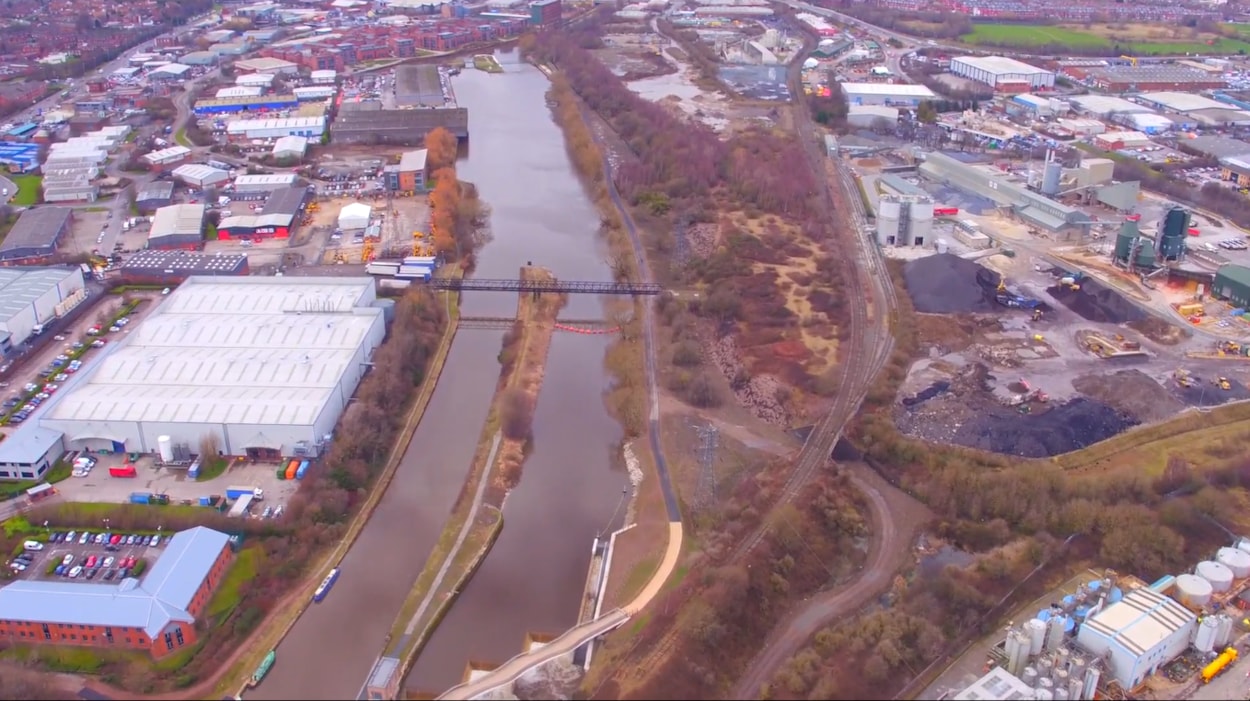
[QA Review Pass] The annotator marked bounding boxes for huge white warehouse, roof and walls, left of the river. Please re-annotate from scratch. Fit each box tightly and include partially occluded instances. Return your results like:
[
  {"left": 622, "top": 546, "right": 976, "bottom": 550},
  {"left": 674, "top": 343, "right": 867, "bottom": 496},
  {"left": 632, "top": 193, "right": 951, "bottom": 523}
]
[{"left": 36, "top": 276, "right": 386, "bottom": 457}]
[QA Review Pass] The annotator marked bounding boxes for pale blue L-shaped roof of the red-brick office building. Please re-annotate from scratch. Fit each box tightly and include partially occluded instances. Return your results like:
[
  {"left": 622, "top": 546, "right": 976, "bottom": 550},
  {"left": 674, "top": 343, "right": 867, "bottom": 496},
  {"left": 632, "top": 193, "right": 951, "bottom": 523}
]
[{"left": 0, "top": 526, "right": 230, "bottom": 639}]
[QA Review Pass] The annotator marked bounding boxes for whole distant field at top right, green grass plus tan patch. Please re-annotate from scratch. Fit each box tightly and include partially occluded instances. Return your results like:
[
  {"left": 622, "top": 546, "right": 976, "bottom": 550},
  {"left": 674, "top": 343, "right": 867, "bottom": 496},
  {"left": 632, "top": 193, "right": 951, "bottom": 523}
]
[{"left": 960, "top": 24, "right": 1250, "bottom": 56}]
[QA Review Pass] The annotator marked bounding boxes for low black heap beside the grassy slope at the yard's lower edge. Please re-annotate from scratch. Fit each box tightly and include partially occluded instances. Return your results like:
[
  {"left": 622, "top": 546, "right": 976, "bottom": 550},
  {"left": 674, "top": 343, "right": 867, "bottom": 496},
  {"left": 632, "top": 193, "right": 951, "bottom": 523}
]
[{"left": 951, "top": 397, "right": 1139, "bottom": 457}]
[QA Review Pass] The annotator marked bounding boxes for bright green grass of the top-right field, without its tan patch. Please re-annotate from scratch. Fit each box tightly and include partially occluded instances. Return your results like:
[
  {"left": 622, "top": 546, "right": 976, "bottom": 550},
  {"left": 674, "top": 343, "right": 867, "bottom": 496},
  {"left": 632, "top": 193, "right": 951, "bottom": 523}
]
[{"left": 960, "top": 24, "right": 1250, "bottom": 56}]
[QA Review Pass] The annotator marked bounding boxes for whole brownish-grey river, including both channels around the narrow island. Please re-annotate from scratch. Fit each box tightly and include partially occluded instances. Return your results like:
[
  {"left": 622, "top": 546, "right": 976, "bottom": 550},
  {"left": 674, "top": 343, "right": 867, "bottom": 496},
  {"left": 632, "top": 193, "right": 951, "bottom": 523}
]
[{"left": 248, "top": 54, "right": 628, "bottom": 699}]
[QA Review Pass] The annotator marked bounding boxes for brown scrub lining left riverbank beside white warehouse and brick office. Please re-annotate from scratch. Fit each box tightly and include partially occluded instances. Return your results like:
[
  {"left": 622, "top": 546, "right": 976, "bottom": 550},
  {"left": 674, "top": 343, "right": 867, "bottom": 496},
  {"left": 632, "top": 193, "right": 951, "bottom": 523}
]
[{"left": 0, "top": 289, "right": 448, "bottom": 694}]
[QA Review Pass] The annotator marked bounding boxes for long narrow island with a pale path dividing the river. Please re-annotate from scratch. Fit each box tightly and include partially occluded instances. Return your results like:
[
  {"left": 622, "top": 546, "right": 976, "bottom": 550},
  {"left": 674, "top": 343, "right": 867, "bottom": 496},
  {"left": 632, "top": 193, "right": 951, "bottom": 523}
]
[{"left": 384, "top": 266, "right": 568, "bottom": 677}]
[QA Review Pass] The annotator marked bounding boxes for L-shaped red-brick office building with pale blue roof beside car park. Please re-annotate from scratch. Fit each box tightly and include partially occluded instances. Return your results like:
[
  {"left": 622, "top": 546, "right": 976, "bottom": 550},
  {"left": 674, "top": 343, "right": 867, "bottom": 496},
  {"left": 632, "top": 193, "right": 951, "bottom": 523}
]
[{"left": 0, "top": 526, "right": 233, "bottom": 657}]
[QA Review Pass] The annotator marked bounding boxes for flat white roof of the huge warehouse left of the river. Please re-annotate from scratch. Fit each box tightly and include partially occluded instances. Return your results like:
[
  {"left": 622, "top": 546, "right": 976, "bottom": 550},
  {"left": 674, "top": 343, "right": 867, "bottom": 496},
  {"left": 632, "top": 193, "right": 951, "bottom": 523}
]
[{"left": 44, "top": 274, "right": 380, "bottom": 427}]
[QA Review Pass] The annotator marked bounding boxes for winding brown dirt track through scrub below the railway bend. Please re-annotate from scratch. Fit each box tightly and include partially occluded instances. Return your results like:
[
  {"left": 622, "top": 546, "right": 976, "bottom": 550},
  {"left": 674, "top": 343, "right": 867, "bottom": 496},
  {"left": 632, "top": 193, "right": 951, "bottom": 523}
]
[{"left": 730, "top": 462, "right": 931, "bottom": 699}]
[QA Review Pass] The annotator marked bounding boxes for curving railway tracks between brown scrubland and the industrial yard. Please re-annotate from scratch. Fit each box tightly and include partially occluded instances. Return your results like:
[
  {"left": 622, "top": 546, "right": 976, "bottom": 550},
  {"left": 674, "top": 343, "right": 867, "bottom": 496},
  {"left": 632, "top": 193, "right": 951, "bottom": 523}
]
[{"left": 734, "top": 49, "right": 895, "bottom": 560}]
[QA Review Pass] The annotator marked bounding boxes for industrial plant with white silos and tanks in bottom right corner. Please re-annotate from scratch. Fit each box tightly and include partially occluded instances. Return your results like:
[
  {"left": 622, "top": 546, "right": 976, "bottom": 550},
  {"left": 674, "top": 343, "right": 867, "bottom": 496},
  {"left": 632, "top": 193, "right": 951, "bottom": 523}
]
[{"left": 921, "top": 537, "right": 1250, "bottom": 701}]
